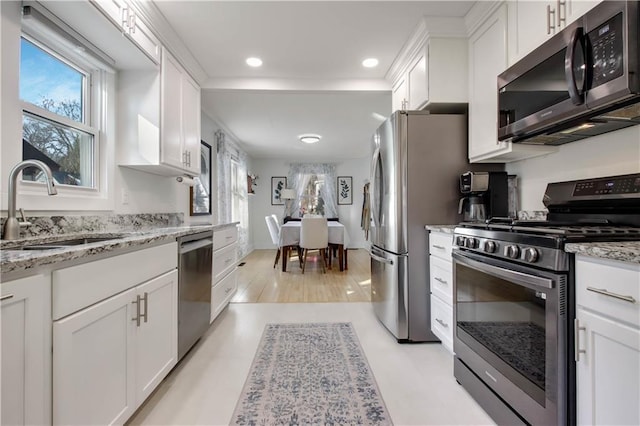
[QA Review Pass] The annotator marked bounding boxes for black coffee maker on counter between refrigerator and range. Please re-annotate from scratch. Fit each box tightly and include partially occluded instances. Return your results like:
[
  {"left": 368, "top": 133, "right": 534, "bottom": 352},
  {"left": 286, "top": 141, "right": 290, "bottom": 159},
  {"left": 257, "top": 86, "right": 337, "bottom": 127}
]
[{"left": 458, "top": 172, "right": 509, "bottom": 222}]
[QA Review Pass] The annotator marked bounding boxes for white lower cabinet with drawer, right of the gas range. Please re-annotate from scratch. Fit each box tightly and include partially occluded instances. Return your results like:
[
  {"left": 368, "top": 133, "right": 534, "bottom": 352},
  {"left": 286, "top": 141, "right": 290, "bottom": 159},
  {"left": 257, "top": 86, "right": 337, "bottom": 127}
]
[{"left": 575, "top": 256, "right": 640, "bottom": 425}]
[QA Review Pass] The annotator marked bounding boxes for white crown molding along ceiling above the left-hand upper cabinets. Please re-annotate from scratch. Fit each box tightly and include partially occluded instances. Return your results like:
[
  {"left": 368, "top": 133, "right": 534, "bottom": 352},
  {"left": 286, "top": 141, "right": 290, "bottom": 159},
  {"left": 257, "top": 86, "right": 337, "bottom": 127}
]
[{"left": 129, "top": 0, "right": 209, "bottom": 85}]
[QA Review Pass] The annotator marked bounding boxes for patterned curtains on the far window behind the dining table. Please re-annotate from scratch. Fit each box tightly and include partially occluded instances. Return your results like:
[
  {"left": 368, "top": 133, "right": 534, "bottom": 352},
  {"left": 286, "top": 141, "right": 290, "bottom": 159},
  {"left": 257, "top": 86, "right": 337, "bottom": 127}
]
[{"left": 287, "top": 163, "right": 338, "bottom": 217}]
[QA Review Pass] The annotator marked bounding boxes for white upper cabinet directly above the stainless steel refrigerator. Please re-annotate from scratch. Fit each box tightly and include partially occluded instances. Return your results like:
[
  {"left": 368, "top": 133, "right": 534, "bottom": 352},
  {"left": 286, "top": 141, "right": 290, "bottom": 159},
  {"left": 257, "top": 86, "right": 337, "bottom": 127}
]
[{"left": 387, "top": 18, "right": 468, "bottom": 111}]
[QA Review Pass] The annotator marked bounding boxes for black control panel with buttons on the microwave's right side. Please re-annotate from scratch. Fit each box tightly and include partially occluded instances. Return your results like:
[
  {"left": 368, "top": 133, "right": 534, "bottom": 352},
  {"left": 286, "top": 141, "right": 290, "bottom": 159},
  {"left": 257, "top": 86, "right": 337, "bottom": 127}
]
[{"left": 588, "top": 13, "right": 624, "bottom": 87}]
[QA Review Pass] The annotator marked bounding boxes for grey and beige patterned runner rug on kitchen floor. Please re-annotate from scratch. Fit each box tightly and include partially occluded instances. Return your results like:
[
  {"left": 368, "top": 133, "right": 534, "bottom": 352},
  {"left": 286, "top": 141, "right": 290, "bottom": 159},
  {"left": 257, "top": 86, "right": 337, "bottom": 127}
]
[{"left": 231, "top": 323, "right": 392, "bottom": 425}]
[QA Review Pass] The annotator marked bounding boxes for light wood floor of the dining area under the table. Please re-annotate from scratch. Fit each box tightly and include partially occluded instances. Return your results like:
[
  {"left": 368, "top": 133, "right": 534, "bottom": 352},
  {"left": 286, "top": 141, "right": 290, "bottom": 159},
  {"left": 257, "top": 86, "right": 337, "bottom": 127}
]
[{"left": 231, "top": 250, "right": 371, "bottom": 303}]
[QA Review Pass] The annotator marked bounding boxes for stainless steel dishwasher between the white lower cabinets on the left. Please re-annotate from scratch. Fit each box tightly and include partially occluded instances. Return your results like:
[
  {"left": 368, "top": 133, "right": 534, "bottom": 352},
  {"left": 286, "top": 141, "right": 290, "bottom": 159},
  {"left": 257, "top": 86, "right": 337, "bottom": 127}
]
[{"left": 178, "top": 231, "right": 213, "bottom": 360}]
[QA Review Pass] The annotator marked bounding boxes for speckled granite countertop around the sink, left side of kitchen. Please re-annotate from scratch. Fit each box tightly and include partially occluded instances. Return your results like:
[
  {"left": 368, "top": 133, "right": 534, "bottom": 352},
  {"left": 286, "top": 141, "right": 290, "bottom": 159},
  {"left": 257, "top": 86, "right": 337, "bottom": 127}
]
[{"left": 0, "top": 222, "right": 237, "bottom": 274}]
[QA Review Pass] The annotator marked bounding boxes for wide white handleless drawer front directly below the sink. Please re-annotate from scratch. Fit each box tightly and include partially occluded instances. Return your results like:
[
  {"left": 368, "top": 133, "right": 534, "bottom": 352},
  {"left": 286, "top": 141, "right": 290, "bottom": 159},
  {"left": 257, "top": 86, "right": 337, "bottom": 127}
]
[{"left": 52, "top": 242, "right": 178, "bottom": 320}]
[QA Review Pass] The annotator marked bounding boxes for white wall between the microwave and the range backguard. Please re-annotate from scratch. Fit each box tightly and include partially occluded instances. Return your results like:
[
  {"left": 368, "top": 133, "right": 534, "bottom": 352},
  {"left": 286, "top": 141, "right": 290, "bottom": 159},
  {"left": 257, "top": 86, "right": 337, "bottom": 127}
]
[{"left": 506, "top": 126, "right": 640, "bottom": 210}]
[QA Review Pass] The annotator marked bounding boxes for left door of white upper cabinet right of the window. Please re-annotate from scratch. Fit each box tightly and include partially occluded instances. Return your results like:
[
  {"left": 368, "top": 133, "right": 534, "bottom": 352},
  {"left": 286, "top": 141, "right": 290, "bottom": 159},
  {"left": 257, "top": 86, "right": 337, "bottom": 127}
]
[{"left": 160, "top": 48, "right": 185, "bottom": 169}]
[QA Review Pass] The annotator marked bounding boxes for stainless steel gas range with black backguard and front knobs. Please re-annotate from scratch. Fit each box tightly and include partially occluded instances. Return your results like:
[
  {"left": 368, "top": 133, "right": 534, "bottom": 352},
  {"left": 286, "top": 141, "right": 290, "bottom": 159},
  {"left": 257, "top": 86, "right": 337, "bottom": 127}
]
[{"left": 453, "top": 174, "right": 640, "bottom": 425}]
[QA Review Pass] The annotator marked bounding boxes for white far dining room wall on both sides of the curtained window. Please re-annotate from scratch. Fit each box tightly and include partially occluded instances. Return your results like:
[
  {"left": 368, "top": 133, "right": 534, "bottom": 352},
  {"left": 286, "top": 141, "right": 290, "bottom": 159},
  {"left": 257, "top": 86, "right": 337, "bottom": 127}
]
[{"left": 249, "top": 157, "right": 369, "bottom": 249}]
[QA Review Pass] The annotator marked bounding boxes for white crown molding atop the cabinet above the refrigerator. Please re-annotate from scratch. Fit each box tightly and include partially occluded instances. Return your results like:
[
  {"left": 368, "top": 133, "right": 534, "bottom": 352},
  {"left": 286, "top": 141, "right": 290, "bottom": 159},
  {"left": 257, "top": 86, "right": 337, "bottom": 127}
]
[{"left": 385, "top": 16, "right": 467, "bottom": 84}]
